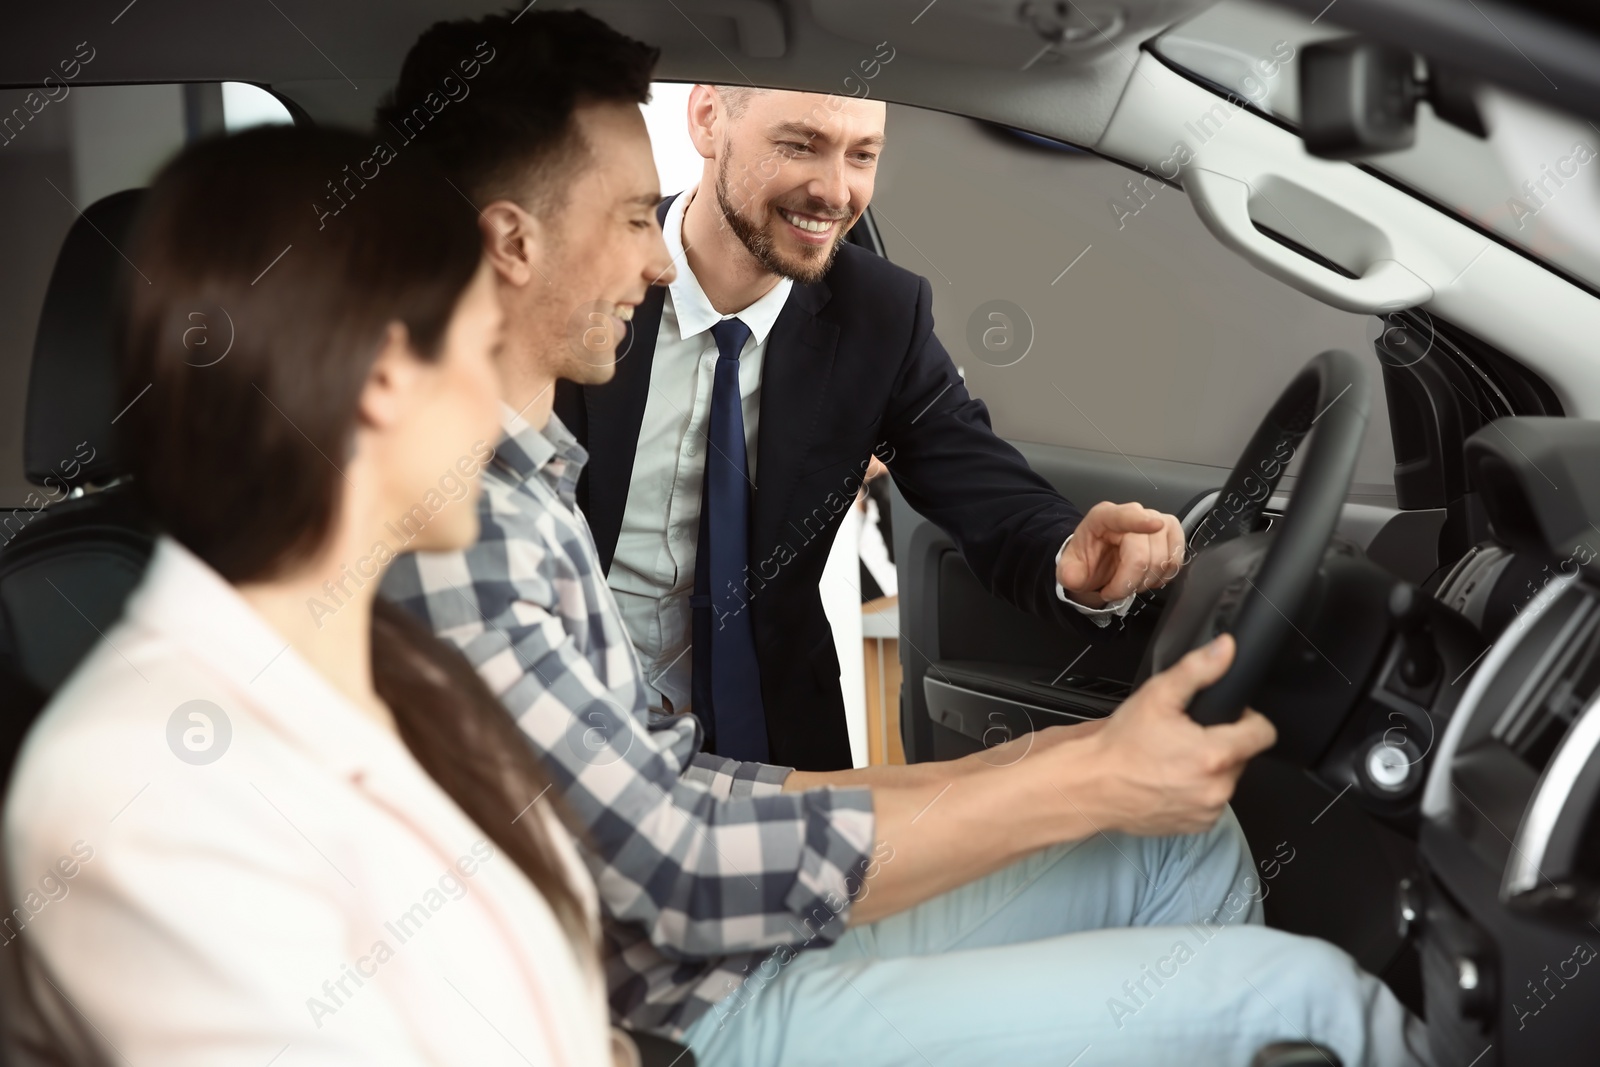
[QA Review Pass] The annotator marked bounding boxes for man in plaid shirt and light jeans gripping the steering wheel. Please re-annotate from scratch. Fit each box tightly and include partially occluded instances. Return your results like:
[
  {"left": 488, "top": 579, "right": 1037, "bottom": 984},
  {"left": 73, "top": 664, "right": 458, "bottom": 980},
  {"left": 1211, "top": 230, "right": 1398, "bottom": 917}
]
[{"left": 379, "top": 13, "right": 1422, "bottom": 1067}]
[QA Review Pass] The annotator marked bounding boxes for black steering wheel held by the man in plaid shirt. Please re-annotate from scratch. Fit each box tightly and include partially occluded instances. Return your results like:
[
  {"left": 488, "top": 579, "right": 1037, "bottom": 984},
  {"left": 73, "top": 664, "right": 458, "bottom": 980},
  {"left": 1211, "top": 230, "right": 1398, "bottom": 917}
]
[{"left": 1149, "top": 349, "right": 1368, "bottom": 725}]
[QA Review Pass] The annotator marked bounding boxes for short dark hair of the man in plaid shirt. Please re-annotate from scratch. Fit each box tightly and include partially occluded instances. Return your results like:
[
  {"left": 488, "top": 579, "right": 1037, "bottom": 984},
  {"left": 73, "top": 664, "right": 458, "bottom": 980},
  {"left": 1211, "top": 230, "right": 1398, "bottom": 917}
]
[{"left": 376, "top": 11, "right": 661, "bottom": 214}]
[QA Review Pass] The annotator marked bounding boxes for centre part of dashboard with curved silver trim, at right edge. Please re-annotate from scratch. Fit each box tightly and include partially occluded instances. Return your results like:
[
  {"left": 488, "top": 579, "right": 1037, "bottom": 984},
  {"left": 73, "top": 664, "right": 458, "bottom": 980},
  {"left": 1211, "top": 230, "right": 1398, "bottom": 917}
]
[{"left": 1398, "top": 419, "right": 1600, "bottom": 1064}]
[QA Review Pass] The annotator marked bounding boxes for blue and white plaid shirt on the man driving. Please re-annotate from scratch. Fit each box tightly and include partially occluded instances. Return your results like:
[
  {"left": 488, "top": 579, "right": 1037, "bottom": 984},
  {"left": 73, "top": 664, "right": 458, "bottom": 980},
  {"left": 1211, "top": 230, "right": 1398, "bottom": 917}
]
[{"left": 382, "top": 408, "right": 874, "bottom": 1033}]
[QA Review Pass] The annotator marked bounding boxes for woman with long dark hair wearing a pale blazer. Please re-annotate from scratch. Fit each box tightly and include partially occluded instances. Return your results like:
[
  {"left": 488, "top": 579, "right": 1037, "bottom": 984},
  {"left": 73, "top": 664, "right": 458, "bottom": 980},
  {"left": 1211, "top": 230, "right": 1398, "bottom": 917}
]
[{"left": 0, "top": 128, "right": 611, "bottom": 1067}]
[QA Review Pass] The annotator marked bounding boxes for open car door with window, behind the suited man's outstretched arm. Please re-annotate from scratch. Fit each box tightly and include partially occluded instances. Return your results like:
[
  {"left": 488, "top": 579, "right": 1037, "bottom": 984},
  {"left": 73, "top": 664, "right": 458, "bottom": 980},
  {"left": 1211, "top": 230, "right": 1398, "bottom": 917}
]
[{"left": 874, "top": 99, "right": 1420, "bottom": 761}]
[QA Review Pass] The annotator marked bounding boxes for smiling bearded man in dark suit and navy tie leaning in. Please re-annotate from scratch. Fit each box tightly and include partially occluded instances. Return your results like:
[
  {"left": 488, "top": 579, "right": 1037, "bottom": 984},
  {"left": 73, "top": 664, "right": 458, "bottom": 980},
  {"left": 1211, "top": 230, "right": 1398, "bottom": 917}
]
[{"left": 555, "top": 85, "right": 1184, "bottom": 769}]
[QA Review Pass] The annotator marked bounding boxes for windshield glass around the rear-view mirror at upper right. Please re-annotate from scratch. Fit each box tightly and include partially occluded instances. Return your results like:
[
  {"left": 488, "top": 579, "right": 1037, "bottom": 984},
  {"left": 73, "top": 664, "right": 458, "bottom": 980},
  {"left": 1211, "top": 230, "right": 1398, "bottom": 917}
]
[{"left": 1154, "top": 0, "right": 1600, "bottom": 288}]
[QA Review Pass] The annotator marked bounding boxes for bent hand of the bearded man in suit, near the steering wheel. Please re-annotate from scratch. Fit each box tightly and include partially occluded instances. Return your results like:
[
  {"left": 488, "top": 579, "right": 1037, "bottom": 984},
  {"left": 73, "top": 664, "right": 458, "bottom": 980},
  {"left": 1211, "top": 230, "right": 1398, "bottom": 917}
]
[{"left": 1056, "top": 501, "right": 1184, "bottom": 608}]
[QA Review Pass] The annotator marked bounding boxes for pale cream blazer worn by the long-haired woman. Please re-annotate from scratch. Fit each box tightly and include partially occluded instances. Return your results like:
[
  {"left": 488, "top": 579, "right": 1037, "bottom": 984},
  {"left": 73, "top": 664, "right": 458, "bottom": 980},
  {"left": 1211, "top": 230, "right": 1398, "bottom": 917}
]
[{"left": 0, "top": 539, "right": 611, "bottom": 1067}]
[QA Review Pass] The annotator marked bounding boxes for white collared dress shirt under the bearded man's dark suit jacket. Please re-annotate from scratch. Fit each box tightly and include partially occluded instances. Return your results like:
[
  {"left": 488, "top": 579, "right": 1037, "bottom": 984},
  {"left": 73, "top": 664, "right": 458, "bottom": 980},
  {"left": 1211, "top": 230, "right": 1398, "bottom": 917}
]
[{"left": 606, "top": 189, "right": 794, "bottom": 709}]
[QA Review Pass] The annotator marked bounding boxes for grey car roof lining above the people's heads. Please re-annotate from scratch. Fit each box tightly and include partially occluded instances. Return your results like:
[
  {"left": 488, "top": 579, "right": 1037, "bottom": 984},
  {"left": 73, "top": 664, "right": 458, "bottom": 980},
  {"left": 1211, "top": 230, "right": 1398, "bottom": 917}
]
[{"left": 0, "top": 0, "right": 1210, "bottom": 144}]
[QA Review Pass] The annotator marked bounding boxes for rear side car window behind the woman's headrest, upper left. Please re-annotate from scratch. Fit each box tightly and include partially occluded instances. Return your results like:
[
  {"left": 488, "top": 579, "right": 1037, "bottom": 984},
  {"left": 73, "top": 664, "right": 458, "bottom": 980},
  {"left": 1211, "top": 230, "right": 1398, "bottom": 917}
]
[{"left": 0, "top": 83, "right": 293, "bottom": 507}]
